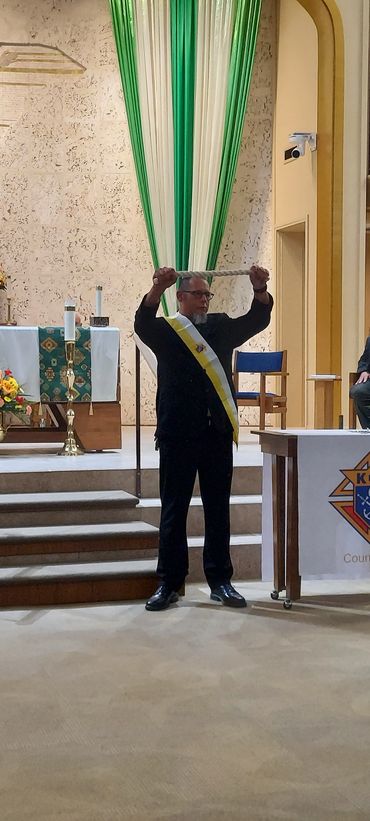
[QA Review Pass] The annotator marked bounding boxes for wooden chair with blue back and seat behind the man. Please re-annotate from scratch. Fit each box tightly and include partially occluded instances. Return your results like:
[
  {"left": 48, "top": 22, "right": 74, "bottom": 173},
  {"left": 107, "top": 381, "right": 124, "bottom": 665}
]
[{"left": 233, "top": 350, "right": 288, "bottom": 430}]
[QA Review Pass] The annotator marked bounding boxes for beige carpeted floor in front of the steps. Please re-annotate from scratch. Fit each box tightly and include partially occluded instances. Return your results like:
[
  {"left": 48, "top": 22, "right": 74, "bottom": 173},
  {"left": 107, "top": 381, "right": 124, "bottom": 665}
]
[{"left": 0, "top": 583, "right": 370, "bottom": 821}]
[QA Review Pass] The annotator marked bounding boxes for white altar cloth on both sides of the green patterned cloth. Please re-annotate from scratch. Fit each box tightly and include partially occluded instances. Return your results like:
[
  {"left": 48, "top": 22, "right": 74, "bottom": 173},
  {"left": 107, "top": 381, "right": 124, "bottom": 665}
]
[{"left": 0, "top": 325, "right": 119, "bottom": 402}]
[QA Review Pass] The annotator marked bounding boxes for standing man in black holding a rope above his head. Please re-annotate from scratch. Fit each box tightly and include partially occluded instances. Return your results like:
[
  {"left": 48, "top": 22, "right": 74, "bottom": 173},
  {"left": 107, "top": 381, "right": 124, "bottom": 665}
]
[{"left": 135, "top": 265, "right": 273, "bottom": 610}]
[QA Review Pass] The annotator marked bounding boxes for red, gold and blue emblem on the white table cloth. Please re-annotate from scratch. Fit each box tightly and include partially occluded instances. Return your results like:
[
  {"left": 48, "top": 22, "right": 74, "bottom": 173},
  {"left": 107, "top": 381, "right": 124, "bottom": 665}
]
[{"left": 329, "top": 452, "right": 370, "bottom": 543}]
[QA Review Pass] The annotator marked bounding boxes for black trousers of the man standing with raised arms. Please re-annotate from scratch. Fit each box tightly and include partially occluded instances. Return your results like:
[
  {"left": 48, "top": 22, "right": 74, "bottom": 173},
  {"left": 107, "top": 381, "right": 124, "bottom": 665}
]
[{"left": 157, "top": 425, "right": 233, "bottom": 590}]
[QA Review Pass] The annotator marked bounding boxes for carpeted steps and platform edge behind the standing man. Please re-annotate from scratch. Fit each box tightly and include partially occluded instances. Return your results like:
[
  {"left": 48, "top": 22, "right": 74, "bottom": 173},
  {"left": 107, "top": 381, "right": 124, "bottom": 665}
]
[{"left": 0, "top": 427, "right": 262, "bottom": 606}]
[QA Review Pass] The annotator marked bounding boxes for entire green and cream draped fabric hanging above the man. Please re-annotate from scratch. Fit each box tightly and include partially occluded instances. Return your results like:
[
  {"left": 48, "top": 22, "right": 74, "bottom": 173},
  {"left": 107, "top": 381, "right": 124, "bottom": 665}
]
[{"left": 109, "top": 0, "right": 261, "bottom": 315}]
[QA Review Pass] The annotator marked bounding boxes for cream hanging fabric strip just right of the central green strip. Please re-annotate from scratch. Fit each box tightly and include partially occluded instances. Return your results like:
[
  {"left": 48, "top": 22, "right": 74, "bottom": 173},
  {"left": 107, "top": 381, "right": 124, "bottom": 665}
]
[{"left": 188, "top": 0, "right": 234, "bottom": 271}]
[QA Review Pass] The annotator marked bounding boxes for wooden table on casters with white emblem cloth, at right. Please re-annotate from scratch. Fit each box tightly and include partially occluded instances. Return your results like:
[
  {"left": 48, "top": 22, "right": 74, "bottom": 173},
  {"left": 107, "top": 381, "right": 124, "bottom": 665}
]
[{"left": 259, "top": 430, "right": 370, "bottom": 607}]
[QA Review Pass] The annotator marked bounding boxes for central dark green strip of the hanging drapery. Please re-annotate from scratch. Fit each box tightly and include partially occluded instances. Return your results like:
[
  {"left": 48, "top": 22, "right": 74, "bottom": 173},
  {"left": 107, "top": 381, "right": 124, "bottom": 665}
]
[{"left": 170, "top": 0, "right": 198, "bottom": 271}]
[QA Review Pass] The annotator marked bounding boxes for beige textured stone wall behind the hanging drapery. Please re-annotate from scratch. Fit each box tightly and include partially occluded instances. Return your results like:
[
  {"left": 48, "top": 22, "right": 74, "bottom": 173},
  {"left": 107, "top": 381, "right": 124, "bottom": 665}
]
[{"left": 0, "top": 0, "right": 275, "bottom": 424}]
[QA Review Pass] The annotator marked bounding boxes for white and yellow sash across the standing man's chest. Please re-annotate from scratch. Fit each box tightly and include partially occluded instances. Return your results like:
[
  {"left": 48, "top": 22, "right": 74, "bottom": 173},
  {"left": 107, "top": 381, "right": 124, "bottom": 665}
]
[{"left": 164, "top": 313, "right": 239, "bottom": 444}]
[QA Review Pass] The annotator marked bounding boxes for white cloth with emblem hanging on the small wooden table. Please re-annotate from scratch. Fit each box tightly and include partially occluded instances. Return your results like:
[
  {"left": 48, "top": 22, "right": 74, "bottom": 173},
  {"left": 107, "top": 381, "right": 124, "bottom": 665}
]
[{"left": 262, "top": 429, "right": 370, "bottom": 580}]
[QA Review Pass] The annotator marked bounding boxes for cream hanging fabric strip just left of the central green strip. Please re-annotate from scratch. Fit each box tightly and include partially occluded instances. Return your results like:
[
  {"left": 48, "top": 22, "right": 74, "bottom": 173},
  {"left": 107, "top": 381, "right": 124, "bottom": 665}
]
[{"left": 134, "top": 0, "right": 176, "bottom": 312}]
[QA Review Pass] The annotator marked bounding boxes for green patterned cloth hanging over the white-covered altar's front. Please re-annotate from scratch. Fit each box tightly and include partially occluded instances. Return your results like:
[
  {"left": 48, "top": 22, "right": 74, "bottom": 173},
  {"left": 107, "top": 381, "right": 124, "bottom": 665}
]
[{"left": 39, "top": 328, "right": 91, "bottom": 402}]
